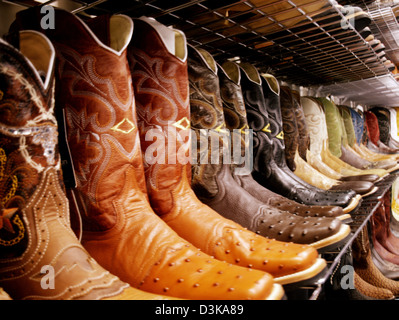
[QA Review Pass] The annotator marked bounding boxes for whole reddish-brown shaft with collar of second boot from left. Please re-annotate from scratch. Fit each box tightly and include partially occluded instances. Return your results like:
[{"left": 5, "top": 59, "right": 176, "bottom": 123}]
[{"left": 13, "top": 8, "right": 150, "bottom": 230}]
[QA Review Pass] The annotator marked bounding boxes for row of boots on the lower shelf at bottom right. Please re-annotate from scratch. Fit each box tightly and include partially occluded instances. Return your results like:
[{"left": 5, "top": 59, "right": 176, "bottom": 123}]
[{"left": 326, "top": 178, "right": 399, "bottom": 300}]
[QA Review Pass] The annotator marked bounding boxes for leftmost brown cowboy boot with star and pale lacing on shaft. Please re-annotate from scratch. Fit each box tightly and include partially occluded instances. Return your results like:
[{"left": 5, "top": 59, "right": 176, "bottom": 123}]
[{"left": 0, "top": 31, "right": 176, "bottom": 300}]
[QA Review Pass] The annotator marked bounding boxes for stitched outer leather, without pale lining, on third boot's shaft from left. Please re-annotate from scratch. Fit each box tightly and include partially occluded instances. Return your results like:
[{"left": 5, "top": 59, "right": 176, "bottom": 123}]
[{"left": 128, "top": 20, "right": 191, "bottom": 215}]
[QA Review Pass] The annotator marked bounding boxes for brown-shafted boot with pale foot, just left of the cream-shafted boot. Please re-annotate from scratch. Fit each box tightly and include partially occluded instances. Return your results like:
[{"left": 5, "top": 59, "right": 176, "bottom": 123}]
[{"left": 281, "top": 87, "right": 377, "bottom": 197}]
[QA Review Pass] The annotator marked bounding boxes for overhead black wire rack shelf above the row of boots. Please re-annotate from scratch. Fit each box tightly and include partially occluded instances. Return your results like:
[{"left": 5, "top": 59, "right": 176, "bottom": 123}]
[{"left": 3, "top": 0, "right": 394, "bottom": 86}]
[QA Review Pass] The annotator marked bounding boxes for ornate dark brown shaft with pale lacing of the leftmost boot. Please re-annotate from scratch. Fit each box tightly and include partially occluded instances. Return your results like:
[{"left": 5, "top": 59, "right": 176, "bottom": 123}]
[{"left": 0, "top": 32, "right": 58, "bottom": 258}]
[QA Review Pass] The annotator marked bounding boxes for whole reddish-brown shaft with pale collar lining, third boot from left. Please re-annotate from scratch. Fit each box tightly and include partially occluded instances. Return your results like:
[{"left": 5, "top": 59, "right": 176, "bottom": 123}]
[{"left": 128, "top": 18, "right": 191, "bottom": 218}]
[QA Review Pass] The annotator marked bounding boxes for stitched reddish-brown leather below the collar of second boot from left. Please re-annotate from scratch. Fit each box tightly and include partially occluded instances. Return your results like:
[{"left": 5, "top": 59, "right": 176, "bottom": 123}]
[{"left": 58, "top": 46, "right": 145, "bottom": 230}]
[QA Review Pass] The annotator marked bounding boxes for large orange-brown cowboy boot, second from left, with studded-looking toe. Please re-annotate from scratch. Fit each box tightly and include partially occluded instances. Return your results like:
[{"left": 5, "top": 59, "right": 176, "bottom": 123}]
[{"left": 10, "top": 9, "right": 283, "bottom": 299}]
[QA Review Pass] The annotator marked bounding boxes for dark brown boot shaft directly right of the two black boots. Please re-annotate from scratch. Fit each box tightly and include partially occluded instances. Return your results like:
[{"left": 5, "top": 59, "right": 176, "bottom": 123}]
[{"left": 280, "top": 86, "right": 299, "bottom": 171}]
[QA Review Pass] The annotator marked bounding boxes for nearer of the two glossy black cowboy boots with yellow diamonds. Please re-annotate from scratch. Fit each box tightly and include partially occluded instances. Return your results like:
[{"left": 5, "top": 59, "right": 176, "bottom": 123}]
[{"left": 240, "top": 64, "right": 360, "bottom": 212}]
